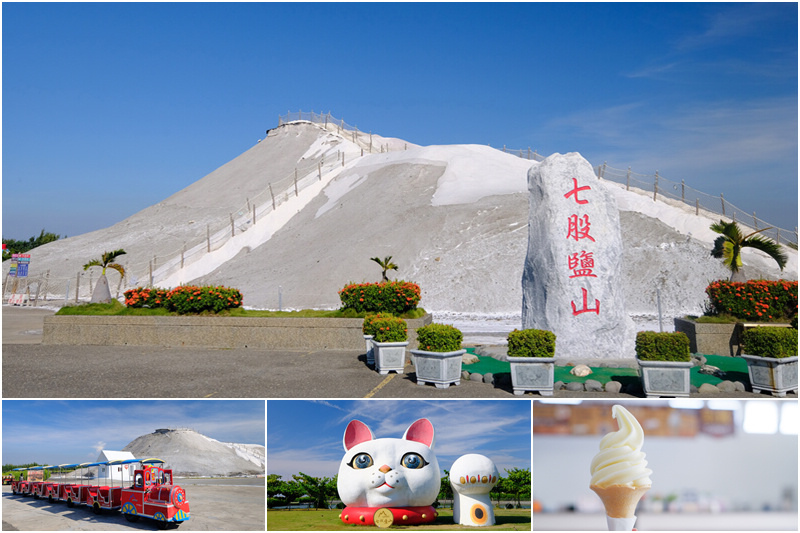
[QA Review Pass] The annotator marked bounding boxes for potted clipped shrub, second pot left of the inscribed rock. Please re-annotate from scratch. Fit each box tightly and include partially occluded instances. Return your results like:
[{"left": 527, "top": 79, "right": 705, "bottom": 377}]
[{"left": 411, "top": 323, "right": 466, "bottom": 389}]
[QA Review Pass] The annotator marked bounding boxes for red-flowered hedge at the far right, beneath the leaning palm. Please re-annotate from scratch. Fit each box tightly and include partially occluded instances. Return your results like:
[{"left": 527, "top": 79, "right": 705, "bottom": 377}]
[{"left": 706, "top": 280, "right": 797, "bottom": 322}]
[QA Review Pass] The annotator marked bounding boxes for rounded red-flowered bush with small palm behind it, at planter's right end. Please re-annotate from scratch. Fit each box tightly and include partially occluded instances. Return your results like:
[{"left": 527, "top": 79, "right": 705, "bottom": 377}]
[{"left": 339, "top": 281, "right": 421, "bottom": 315}]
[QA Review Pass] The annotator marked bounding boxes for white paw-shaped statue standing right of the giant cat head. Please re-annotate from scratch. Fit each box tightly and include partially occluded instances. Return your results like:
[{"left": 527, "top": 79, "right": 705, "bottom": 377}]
[{"left": 450, "top": 453, "right": 499, "bottom": 526}]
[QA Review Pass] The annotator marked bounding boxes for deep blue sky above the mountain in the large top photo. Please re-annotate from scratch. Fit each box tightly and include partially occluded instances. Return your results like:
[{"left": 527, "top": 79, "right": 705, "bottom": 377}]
[{"left": 2, "top": 3, "right": 798, "bottom": 239}]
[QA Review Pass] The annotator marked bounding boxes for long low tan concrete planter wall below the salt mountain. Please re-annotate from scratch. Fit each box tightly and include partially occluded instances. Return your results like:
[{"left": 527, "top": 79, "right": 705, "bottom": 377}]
[{"left": 42, "top": 315, "right": 432, "bottom": 351}]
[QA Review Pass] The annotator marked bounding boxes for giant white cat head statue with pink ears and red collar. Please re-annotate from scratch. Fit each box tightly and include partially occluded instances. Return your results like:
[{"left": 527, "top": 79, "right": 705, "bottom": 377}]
[{"left": 337, "top": 418, "right": 441, "bottom": 527}]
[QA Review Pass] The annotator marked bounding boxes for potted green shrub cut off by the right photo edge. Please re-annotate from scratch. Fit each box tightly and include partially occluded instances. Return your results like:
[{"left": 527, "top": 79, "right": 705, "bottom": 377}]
[{"left": 742, "top": 326, "right": 797, "bottom": 397}]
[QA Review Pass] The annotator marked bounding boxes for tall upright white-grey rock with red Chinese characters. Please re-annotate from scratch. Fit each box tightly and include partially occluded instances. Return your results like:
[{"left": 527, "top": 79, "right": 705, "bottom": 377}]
[{"left": 522, "top": 153, "right": 635, "bottom": 359}]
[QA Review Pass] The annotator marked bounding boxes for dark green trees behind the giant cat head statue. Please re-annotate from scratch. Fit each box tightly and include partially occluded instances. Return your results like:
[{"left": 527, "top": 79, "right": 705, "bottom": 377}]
[{"left": 267, "top": 468, "right": 531, "bottom": 509}]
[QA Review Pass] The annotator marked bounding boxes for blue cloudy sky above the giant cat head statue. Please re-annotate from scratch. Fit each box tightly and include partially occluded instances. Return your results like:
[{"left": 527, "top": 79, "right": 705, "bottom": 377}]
[{"left": 267, "top": 400, "right": 531, "bottom": 479}]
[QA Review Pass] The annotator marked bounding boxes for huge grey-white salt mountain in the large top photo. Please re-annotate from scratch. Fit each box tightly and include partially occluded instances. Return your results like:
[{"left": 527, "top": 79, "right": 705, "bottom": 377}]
[{"left": 12, "top": 122, "right": 797, "bottom": 336}]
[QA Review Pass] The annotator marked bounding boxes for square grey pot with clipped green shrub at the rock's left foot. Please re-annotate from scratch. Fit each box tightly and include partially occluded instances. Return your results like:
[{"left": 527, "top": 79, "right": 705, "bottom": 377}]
[{"left": 507, "top": 329, "right": 556, "bottom": 396}]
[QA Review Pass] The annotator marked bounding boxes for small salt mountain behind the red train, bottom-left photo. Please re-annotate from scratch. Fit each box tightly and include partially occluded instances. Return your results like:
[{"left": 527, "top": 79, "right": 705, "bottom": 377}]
[{"left": 123, "top": 429, "right": 266, "bottom": 477}]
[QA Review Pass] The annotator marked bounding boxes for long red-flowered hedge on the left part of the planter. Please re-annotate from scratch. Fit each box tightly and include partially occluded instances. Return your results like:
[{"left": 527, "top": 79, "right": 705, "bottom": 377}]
[{"left": 125, "top": 286, "right": 242, "bottom": 315}]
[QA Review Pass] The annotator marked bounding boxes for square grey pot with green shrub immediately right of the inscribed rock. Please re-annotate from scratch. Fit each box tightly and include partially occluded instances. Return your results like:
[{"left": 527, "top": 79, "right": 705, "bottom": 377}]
[{"left": 636, "top": 331, "right": 693, "bottom": 398}]
